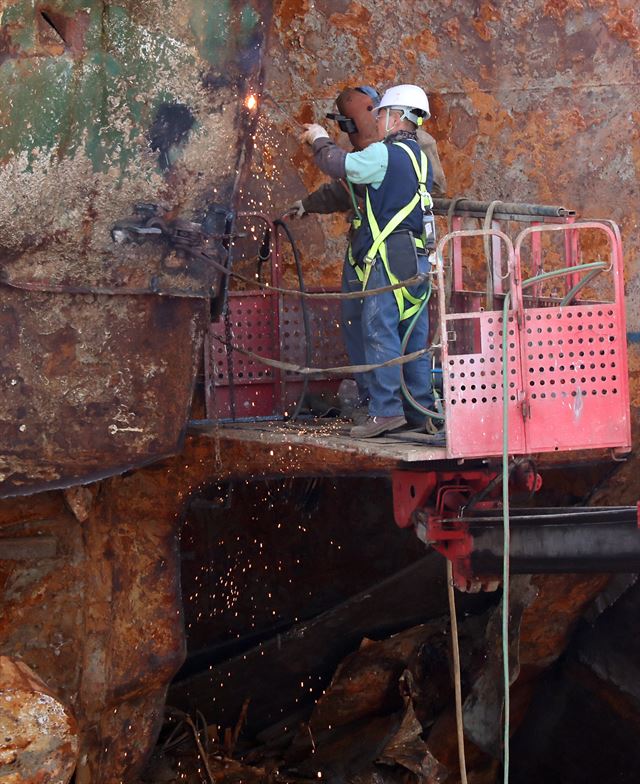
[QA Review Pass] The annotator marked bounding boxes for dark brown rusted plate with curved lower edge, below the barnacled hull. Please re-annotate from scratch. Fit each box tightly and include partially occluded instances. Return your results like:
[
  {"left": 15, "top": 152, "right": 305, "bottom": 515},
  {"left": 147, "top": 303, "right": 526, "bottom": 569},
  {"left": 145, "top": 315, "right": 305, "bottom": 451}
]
[{"left": 0, "top": 289, "right": 205, "bottom": 497}]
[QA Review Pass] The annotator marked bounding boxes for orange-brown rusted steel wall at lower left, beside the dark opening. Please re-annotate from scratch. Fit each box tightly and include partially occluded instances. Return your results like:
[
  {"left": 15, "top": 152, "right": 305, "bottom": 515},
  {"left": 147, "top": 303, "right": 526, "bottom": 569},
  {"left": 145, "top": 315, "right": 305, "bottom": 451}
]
[{"left": 0, "top": 456, "right": 205, "bottom": 784}]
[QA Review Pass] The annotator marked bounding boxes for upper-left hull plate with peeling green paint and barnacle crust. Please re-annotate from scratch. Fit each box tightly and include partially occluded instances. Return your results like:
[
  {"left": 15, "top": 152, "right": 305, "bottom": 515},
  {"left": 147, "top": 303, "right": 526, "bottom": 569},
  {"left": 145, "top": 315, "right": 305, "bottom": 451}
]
[{"left": 0, "top": 0, "right": 264, "bottom": 287}]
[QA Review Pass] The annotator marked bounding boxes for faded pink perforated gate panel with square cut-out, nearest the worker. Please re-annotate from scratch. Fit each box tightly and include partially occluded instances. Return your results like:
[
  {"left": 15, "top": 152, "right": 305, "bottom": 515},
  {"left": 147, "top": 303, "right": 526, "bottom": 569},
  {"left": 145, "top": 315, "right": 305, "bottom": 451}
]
[{"left": 444, "top": 311, "right": 525, "bottom": 457}]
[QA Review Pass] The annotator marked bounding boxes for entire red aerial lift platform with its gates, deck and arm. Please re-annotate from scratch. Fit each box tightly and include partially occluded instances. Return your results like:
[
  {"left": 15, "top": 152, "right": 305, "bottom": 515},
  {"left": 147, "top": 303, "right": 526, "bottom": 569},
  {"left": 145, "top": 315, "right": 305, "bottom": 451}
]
[{"left": 146, "top": 199, "right": 640, "bottom": 590}]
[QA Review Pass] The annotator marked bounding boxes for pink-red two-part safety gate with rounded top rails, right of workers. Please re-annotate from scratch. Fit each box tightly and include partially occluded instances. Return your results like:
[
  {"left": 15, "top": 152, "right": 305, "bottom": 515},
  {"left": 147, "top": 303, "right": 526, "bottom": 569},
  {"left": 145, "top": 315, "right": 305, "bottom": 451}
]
[{"left": 439, "top": 221, "right": 631, "bottom": 457}]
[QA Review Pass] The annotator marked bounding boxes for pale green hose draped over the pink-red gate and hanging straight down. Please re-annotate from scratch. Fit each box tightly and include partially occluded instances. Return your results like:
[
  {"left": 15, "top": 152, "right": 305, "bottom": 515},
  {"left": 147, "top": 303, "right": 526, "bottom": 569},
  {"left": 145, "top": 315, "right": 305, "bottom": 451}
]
[{"left": 502, "top": 261, "right": 609, "bottom": 784}]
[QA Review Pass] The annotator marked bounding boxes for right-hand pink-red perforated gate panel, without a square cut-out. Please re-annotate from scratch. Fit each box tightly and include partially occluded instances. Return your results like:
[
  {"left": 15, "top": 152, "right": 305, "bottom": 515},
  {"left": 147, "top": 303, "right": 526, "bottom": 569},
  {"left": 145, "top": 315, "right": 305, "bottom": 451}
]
[{"left": 523, "top": 305, "right": 629, "bottom": 452}]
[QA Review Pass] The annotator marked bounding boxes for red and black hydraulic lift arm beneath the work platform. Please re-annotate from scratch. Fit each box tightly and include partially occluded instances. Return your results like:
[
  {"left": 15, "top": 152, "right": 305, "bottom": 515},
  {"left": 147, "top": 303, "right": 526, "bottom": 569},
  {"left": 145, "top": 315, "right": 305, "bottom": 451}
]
[{"left": 393, "top": 471, "right": 640, "bottom": 591}]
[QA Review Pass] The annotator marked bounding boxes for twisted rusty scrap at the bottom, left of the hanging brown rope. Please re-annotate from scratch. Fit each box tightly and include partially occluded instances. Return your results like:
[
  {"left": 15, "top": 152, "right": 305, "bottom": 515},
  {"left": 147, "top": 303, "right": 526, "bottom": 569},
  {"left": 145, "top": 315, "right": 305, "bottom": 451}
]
[{"left": 150, "top": 618, "right": 497, "bottom": 784}]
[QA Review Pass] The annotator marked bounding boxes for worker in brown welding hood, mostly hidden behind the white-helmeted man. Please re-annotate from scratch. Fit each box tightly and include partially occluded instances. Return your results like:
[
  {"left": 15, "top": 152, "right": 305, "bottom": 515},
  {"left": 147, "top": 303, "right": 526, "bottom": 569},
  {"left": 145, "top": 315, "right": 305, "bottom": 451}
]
[{"left": 288, "top": 85, "right": 446, "bottom": 424}]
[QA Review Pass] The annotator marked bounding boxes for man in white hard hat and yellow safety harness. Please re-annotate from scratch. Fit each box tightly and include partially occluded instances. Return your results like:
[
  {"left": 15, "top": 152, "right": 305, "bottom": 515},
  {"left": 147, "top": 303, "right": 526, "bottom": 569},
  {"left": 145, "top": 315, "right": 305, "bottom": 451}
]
[{"left": 302, "top": 85, "right": 433, "bottom": 438}]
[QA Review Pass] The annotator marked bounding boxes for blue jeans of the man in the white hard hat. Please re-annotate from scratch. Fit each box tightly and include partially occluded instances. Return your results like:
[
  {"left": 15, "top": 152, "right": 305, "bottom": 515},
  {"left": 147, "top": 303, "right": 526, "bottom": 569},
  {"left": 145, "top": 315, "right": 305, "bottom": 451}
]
[{"left": 362, "top": 256, "right": 433, "bottom": 424}]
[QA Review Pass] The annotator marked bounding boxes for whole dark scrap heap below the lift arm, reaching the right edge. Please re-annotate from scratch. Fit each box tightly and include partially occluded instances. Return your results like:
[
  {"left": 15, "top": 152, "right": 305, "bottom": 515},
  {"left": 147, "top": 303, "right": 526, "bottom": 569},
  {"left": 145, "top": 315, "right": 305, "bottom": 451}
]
[{"left": 154, "top": 557, "right": 640, "bottom": 784}]
